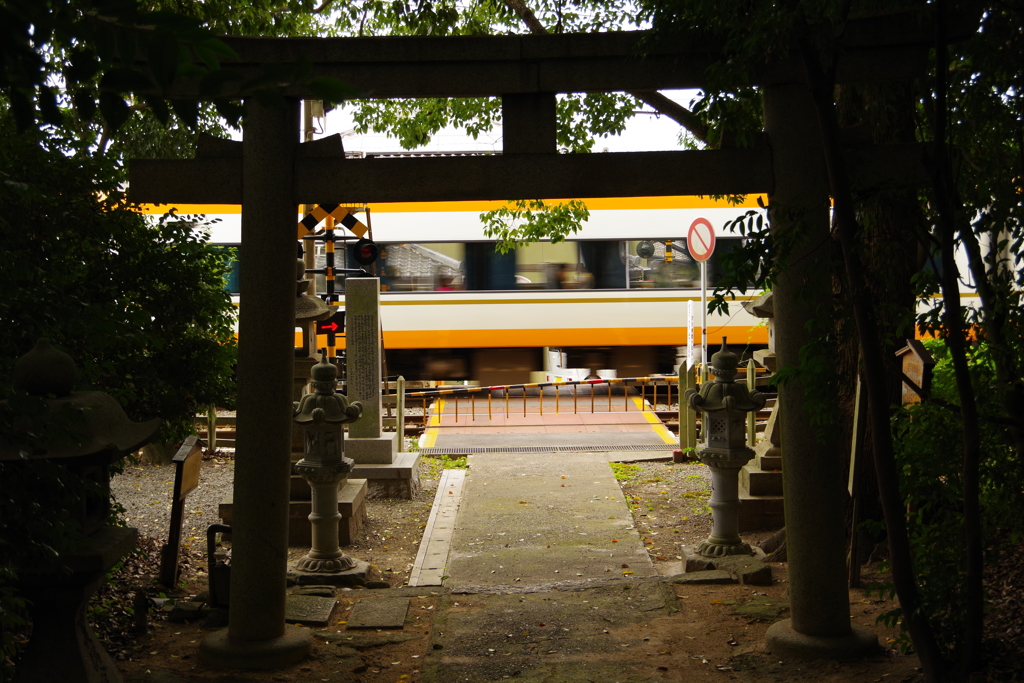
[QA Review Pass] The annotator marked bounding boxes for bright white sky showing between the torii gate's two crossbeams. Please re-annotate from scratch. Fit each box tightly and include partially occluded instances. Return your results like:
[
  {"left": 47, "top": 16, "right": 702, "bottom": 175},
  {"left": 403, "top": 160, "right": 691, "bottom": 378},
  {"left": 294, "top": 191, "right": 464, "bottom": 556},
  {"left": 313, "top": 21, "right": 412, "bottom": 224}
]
[{"left": 316, "top": 90, "right": 696, "bottom": 153}]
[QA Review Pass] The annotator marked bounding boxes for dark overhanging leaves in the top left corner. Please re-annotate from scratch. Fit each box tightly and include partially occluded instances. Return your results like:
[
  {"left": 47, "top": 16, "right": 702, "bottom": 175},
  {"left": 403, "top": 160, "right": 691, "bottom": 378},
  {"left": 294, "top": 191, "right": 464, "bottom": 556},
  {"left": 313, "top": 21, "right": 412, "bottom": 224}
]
[{"left": 0, "top": 0, "right": 339, "bottom": 133}]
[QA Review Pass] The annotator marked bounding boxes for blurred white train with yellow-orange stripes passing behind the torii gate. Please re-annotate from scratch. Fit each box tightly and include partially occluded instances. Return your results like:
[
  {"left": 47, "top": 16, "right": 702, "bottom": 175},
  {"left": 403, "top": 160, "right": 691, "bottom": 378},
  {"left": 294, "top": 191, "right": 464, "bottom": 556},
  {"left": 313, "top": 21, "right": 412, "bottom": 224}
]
[{"left": 142, "top": 197, "right": 768, "bottom": 384}]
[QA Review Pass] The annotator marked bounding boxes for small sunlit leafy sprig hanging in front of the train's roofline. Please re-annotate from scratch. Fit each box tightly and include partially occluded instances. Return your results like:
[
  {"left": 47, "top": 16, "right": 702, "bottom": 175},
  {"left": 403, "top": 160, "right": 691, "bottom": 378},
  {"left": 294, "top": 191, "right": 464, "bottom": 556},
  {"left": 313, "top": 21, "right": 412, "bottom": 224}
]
[{"left": 480, "top": 200, "right": 590, "bottom": 254}]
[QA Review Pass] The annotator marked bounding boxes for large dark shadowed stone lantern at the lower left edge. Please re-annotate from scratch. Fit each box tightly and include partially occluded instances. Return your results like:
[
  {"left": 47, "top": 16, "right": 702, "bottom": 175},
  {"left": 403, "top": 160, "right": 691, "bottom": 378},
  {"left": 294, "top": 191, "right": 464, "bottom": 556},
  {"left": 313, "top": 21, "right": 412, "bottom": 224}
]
[{"left": 0, "top": 339, "right": 161, "bottom": 683}]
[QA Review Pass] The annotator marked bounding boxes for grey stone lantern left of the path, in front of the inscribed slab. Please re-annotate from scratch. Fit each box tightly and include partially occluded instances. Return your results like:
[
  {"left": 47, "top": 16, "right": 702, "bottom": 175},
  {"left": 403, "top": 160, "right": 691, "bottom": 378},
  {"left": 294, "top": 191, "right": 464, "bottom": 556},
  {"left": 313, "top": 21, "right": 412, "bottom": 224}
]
[{"left": 294, "top": 353, "right": 362, "bottom": 573}]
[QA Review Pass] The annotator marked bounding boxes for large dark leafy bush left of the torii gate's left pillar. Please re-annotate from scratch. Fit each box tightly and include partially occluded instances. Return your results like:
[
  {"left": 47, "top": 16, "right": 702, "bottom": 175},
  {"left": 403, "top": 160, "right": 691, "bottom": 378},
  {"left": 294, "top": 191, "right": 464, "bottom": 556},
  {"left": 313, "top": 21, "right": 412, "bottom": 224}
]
[{"left": 0, "top": 111, "right": 234, "bottom": 440}]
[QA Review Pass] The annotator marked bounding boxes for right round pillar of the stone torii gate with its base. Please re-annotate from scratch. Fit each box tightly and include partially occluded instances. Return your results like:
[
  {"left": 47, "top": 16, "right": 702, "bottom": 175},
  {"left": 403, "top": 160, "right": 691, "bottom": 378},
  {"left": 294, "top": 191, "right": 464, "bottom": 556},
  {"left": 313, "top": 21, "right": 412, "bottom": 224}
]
[{"left": 762, "top": 84, "right": 873, "bottom": 657}]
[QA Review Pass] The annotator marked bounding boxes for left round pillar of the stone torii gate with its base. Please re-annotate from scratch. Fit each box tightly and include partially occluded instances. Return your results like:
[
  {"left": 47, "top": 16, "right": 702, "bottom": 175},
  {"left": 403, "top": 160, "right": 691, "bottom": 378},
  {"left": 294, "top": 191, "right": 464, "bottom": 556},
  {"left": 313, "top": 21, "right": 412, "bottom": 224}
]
[{"left": 200, "top": 99, "right": 310, "bottom": 669}]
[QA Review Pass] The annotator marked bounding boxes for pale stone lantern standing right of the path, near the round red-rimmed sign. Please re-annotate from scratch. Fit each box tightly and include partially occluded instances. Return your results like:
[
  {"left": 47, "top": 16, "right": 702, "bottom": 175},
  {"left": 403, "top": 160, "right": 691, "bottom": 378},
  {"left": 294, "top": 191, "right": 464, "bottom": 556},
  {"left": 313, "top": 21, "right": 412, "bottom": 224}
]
[{"left": 685, "top": 337, "right": 765, "bottom": 557}]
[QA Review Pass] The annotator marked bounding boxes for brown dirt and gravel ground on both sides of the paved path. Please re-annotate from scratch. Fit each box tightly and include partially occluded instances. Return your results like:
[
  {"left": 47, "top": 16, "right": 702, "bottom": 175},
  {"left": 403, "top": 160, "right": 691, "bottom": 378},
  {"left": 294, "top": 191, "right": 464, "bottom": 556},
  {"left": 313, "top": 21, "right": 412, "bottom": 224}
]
[{"left": 75, "top": 455, "right": 942, "bottom": 683}]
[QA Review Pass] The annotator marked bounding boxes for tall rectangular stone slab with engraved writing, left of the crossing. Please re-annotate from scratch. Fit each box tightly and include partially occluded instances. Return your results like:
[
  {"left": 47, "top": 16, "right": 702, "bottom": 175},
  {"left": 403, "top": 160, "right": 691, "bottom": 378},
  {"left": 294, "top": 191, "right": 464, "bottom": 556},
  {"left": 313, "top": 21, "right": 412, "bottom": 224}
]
[{"left": 345, "top": 278, "right": 397, "bottom": 464}]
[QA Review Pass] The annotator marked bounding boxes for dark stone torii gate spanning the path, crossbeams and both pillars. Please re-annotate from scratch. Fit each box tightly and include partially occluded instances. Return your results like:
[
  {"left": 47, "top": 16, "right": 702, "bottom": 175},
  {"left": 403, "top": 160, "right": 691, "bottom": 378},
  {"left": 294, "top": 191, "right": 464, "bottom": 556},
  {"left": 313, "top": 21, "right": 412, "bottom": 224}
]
[{"left": 130, "top": 17, "right": 929, "bottom": 669}]
